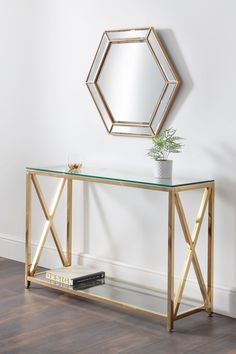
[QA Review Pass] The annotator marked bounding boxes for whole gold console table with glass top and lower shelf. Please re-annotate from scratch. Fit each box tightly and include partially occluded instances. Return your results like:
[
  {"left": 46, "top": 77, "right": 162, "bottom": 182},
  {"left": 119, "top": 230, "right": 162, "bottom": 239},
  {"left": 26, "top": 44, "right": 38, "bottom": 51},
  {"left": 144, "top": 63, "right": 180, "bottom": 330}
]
[{"left": 25, "top": 166, "right": 214, "bottom": 331}]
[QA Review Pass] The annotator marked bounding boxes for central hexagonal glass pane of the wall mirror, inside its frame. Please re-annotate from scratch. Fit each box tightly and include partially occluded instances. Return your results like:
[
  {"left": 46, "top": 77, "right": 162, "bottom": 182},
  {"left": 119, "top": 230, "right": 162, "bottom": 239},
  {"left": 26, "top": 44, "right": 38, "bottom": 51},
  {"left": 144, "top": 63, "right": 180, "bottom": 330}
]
[{"left": 97, "top": 42, "right": 165, "bottom": 123}]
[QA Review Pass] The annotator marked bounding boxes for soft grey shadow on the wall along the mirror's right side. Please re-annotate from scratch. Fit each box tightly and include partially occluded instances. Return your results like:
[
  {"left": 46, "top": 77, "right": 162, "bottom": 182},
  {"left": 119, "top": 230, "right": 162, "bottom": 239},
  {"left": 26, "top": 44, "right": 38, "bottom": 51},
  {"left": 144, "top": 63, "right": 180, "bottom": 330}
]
[{"left": 156, "top": 29, "right": 193, "bottom": 126}]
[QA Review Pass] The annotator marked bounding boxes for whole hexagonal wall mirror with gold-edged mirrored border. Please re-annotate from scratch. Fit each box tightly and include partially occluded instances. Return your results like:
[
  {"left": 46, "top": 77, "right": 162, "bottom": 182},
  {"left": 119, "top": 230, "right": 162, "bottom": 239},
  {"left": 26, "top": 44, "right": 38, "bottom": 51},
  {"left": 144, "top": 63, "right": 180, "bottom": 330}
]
[{"left": 86, "top": 27, "right": 179, "bottom": 137}]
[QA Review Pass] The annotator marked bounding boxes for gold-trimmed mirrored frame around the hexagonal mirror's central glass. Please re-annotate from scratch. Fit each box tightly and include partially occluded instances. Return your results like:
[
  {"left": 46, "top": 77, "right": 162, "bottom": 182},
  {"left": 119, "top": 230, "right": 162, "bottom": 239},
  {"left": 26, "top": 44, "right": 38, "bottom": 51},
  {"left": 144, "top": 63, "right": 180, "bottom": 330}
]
[{"left": 86, "top": 27, "right": 180, "bottom": 137}]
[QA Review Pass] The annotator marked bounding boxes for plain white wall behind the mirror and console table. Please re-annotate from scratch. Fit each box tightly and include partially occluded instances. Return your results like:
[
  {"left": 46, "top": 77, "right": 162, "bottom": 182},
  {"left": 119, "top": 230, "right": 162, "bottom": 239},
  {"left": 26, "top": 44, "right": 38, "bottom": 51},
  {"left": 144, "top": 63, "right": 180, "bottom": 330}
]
[{"left": 0, "top": 0, "right": 236, "bottom": 317}]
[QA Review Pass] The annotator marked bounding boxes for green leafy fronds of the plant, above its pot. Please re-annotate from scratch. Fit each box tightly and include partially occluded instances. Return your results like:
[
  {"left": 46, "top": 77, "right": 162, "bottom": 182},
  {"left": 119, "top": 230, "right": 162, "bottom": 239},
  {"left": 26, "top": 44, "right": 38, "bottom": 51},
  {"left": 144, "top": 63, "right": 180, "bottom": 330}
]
[{"left": 147, "top": 128, "right": 184, "bottom": 161}]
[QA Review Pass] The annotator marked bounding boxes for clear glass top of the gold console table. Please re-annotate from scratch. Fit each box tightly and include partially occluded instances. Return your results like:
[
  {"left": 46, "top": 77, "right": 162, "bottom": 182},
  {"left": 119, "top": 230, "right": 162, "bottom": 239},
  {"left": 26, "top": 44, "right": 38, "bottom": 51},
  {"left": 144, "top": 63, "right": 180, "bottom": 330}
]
[{"left": 26, "top": 165, "right": 214, "bottom": 188}]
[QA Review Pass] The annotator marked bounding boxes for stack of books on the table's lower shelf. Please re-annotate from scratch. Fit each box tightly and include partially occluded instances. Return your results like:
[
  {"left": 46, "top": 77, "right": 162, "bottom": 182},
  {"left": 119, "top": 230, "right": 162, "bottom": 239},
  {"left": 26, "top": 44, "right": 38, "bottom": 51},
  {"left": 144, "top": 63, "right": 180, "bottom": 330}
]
[{"left": 46, "top": 265, "right": 105, "bottom": 290}]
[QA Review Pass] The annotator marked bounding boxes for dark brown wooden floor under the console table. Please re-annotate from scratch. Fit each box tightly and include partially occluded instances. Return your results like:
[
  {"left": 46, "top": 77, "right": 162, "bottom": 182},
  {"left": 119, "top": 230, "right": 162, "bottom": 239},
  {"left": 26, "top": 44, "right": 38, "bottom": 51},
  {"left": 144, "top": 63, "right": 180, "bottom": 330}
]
[{"left": 0, "top": 258, "right": 236, "bottom": 354}]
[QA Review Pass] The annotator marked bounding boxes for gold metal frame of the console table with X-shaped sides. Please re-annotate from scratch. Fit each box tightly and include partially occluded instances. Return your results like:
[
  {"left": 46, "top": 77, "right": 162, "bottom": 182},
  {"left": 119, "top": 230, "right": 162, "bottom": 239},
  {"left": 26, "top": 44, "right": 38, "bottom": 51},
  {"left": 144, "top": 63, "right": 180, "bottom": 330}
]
[{"left": 25, "top": 168, "right": 215, "bottom": 331}]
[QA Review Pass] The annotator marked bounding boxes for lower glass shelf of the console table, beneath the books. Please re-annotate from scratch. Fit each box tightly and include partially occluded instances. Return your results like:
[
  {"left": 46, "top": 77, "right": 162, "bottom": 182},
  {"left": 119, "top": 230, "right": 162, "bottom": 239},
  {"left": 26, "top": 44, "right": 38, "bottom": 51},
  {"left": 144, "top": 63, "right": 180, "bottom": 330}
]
[{"left": 28, "top": 272, "right": 202, "bottom": 318}]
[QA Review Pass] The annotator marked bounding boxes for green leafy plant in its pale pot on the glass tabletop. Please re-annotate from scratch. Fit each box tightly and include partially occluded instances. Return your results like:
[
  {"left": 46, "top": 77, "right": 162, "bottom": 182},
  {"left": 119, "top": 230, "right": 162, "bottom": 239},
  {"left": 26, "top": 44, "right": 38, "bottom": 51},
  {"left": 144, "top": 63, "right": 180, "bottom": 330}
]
[{"left": 147, "top": 128, "right": 183, "bottom": 178}]
